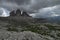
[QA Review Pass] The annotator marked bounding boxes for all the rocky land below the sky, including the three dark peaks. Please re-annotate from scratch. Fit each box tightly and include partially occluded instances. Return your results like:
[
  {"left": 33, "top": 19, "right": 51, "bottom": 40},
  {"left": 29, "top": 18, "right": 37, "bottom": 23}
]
[{"left": 0, "top": 9, "right": 60, "bottom": 40}]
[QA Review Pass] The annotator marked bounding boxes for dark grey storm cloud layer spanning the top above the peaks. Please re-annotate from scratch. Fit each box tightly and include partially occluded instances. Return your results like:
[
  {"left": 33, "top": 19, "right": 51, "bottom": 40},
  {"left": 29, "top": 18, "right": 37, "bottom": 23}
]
[{"left": 0, "top": 0, "right": 60, "bottom": 11}]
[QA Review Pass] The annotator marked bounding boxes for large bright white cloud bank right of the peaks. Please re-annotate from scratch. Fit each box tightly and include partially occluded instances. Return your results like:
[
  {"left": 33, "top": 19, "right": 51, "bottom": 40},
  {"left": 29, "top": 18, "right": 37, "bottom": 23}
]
[{"left": 32, "top": 5, "right": 60, "bottom": 17}]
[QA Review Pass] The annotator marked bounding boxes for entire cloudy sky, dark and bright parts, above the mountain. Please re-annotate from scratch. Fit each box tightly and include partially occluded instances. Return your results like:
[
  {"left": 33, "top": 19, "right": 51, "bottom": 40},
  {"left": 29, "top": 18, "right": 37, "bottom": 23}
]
[{"left": 0, "top": 0, "right": 60, "bottom": 17}]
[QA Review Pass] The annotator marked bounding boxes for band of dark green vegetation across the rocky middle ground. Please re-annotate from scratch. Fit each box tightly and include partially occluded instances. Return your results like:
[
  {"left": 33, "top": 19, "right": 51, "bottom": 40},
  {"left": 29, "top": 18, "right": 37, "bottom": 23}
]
[{"left": 6, "top": 21, "right": 59, "bottom": 36}]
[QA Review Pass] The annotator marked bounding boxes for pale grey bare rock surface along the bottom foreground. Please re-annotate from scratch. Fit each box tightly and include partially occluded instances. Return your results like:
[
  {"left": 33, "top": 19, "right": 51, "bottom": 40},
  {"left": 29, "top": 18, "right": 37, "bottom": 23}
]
[{"left": 0, "top": 30, "right": 54, "bottom": 40}]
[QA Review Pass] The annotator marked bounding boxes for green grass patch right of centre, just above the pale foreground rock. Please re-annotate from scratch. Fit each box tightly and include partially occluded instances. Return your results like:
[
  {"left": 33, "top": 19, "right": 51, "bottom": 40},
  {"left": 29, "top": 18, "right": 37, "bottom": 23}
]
[{"left": 21, "top": 24, "right": 49, "bottom": 35}]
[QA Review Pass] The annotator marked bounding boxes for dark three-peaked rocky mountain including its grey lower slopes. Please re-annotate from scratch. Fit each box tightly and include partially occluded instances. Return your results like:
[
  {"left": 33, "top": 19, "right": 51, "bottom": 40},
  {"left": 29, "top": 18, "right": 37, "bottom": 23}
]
[{"left": 0, "top": 9, "right": 47, "bottom": 23}]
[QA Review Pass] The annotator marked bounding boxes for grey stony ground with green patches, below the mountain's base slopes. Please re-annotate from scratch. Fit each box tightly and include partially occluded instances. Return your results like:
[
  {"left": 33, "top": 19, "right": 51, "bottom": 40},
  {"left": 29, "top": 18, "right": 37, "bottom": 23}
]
[{"left": 0, "top": 18, "right": 60, "bottom": 40}]
